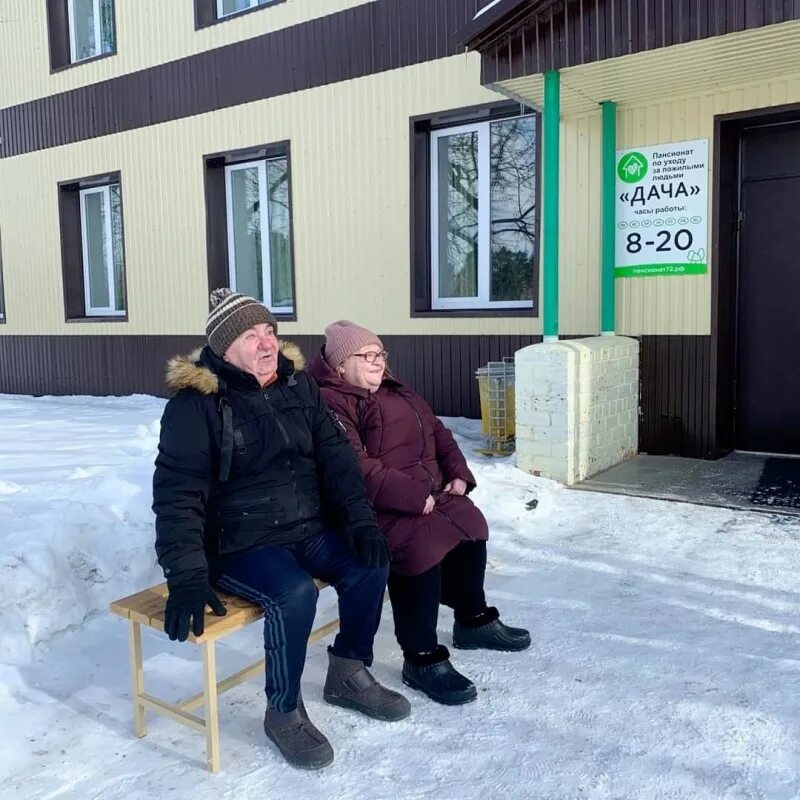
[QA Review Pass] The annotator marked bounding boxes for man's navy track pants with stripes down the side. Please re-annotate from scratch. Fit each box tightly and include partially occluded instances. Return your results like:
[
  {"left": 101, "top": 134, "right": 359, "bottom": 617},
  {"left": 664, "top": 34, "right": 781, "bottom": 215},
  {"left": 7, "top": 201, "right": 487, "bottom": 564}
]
[{"left": 217, "top": 532, "right": 388, "bottom": 711}]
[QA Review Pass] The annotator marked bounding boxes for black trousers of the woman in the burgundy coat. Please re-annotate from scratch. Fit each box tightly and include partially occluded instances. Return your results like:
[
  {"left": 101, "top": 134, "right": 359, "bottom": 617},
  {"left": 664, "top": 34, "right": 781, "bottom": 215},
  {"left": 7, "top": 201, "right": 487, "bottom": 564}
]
[{"left": 389, "top": 541, "right": 486, "bottom": 654}]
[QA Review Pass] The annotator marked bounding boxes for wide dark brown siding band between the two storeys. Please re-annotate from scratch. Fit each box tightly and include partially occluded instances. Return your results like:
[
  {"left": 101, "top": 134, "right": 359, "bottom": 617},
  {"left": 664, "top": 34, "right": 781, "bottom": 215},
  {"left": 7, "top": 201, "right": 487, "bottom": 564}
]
[{"left": 0, "top": 0, "right": 478, "bottom": 158}]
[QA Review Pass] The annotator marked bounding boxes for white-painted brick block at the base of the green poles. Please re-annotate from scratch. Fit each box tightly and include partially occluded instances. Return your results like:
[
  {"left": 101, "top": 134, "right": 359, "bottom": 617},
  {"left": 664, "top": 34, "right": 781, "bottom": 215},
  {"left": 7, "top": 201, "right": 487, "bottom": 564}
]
[{"left": 514, "top": 336, "right": 639, "bottom": 485}]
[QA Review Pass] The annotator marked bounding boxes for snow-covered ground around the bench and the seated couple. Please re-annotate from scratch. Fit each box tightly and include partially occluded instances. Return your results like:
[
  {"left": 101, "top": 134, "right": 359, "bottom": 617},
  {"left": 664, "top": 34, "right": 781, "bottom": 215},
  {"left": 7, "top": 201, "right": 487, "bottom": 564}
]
[{"left": 0, "top": 396, "right": 800, "bottom": 800}]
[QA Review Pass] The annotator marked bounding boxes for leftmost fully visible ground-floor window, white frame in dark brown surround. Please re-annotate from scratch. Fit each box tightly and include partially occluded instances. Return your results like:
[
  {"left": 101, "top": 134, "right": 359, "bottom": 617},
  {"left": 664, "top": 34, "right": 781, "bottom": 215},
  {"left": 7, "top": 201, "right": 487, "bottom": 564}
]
[{"left": 57, "top": 171, "right": 130, "bottom": 323}]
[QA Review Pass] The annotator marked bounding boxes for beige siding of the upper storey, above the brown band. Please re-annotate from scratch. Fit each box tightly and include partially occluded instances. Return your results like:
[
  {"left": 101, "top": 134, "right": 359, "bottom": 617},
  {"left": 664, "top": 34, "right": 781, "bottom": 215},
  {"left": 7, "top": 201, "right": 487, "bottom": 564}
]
[{"left": 0, "top": 0, "right": 372, "bottom": 108}]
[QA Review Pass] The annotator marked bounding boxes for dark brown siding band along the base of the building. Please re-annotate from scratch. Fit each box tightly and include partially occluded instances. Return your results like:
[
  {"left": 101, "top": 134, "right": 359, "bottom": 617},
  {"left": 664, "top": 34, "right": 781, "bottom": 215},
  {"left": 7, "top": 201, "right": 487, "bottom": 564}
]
[{"left": 0, "top": 335, "right": 718, "bottom": 458}]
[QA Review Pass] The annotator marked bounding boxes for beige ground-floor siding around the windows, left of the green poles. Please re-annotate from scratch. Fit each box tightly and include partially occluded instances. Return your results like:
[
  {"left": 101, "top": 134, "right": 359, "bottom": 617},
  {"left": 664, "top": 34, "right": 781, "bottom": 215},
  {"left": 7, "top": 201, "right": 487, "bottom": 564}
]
[{"left": 0, "top": 54, "right": 548, "bottom": 334}]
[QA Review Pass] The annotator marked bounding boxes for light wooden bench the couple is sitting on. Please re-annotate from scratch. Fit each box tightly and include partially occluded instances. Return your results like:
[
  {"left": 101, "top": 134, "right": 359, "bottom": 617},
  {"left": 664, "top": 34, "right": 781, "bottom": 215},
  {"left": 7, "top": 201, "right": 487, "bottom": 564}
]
[{"left": 111, "top": 581, "right": 339, "bottom": 772}]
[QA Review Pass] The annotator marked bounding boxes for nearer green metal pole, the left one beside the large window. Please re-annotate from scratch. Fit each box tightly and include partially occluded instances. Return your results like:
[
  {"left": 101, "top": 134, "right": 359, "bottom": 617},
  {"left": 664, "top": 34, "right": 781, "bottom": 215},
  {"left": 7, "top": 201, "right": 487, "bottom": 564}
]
[{"left": 542, "top": 71, "right": 561, "bottom": 342}]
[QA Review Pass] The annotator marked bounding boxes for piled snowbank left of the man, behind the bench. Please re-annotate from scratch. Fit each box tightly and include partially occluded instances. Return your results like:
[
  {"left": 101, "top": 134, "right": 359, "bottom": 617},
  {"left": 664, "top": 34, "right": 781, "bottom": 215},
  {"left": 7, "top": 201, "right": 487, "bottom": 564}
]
[{"left": 0, "top": 397, "right": 163, "bottom": 665}]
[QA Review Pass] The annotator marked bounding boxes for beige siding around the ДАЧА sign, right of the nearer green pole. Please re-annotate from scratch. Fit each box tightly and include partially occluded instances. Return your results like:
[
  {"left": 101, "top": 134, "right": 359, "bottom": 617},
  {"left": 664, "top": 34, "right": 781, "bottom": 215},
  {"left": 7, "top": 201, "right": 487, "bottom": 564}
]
[{"left": 560, "top": 69, "right": 800, "bottom": 335}]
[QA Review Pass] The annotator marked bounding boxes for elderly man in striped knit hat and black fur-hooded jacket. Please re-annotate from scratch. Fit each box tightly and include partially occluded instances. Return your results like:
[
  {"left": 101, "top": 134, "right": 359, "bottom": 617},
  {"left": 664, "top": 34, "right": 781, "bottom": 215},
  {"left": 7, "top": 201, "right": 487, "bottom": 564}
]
[{"left": 153, "top": 289, "right": 410, "bottom": 769}]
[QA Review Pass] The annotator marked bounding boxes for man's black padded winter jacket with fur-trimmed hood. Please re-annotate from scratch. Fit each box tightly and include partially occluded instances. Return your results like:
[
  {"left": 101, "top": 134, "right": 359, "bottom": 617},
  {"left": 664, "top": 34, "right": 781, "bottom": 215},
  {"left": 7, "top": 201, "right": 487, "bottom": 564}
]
[{"left": 153, "top": 343, "right": 377, "bottom": 587}]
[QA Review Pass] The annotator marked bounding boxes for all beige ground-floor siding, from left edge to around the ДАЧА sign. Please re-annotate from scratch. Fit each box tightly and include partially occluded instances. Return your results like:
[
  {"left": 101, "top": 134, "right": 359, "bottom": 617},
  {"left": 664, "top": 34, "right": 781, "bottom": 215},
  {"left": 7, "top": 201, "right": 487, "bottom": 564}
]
[{"left": 9, "top": 36, "right": 800, "bottom": 335}]
